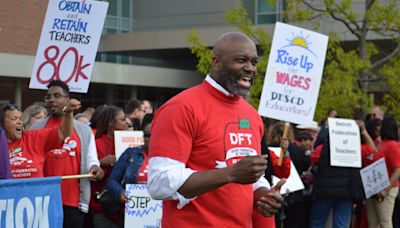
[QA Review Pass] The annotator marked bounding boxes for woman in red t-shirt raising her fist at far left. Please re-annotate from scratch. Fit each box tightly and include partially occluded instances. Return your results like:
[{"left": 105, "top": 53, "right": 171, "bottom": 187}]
[{"left": 1, "top": 99, "right": 80, "bottom": 178}]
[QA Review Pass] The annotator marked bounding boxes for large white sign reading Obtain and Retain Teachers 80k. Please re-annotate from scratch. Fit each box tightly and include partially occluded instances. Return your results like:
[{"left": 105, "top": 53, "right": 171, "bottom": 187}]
[{"left": 29, "top": 0, "right": 108, "bottom": 93}]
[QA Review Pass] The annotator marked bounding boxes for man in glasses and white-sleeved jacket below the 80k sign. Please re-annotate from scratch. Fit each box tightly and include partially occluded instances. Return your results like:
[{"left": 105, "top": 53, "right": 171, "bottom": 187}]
[{"left": 32, "top": 80, "right": 104, "bottom": 227}]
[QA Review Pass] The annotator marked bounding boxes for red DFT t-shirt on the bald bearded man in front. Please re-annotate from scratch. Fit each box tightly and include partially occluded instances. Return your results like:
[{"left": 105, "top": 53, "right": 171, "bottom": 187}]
[{"left": 149, "top": 82, "right": 264, "bottom": 228}]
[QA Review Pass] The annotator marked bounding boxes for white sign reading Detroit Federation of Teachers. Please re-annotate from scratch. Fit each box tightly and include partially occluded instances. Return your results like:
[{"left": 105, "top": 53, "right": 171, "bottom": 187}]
[{"left": 328, "top": 118, "right": 361, "bottom": 168}]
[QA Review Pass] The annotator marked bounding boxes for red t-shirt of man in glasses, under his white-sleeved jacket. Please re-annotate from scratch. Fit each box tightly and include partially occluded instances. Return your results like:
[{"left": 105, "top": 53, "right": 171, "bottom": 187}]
[{"left": 44, "top": 118, "right": 81, "bottom": 207}]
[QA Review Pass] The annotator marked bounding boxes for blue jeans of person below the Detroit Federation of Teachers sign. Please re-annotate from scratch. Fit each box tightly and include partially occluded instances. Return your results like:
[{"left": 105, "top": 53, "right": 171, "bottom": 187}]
[{"left": 310, "top": 199, "right": 353, "bottom": 228}]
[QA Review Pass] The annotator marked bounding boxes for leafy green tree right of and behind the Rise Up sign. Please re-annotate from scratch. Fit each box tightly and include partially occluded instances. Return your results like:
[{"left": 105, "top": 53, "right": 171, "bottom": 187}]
[{"left": 285, "top": 0, "right": 400, "bottom": 119}]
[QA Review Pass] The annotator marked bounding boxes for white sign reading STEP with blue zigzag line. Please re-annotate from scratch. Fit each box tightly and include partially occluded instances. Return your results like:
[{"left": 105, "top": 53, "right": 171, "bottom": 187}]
[{"left": 125, "top": 184, "right": 162, "bottom": 228}]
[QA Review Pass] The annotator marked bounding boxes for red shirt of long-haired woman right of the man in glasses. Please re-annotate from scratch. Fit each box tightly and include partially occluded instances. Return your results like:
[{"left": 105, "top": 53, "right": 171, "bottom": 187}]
[{"left": 89, "top": 135, "right": 115, "bottom": 214}]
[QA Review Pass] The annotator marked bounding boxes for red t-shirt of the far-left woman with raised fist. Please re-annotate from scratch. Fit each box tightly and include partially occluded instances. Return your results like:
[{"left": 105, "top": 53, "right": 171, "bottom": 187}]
[{"left": 8, "top": 128, "right": 60, "bottom": 178}]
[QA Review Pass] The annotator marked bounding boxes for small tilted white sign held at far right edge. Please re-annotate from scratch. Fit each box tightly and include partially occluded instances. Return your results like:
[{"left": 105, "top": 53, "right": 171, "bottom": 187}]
[{"left": 360, "top": 158, "right": 390, "bottom": 199}]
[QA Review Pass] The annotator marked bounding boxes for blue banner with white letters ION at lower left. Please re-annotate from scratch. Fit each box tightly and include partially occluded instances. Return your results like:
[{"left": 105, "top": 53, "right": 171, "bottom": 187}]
[{"left": 0, "top": 177, "right": 63, "bottom": 228}]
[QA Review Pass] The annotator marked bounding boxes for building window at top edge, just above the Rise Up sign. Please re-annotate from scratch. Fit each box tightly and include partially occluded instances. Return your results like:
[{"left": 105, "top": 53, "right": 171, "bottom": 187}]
[{"left": 255, "top": 0, "right": 284, "bottom": 24}]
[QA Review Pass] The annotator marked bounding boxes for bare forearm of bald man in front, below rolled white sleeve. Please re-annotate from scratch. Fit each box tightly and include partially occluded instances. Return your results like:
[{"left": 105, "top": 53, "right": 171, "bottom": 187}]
[{"left": 178, "top": 168, "right": 232, "bottom": 199}]
